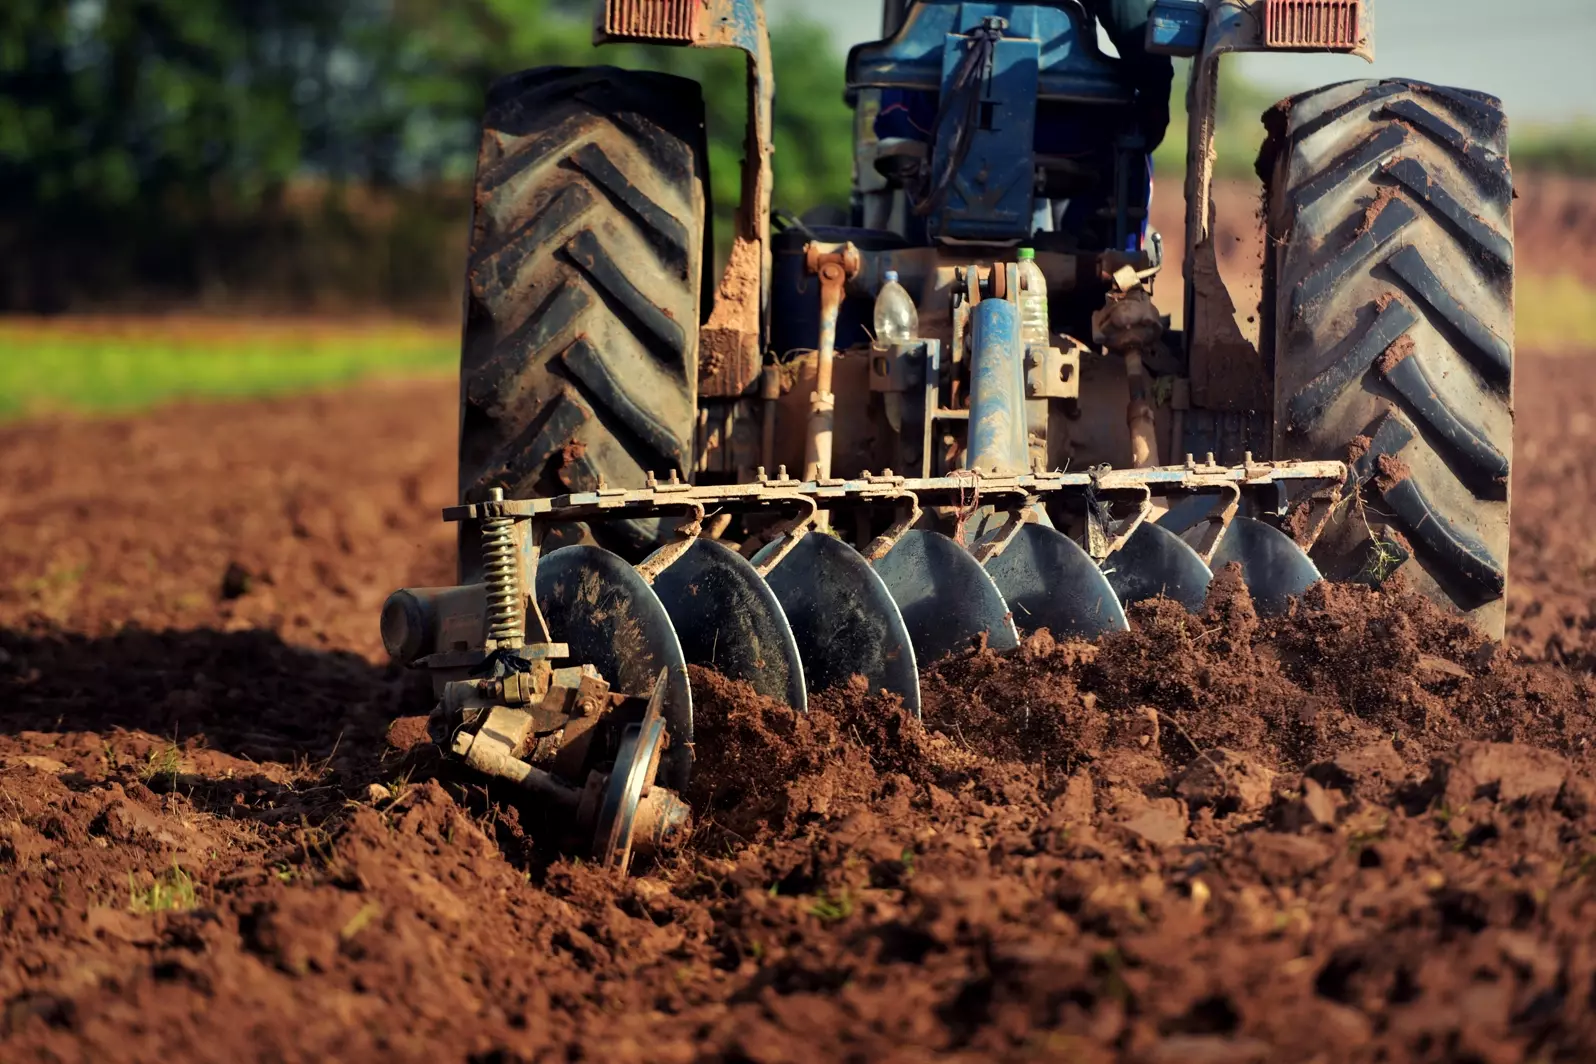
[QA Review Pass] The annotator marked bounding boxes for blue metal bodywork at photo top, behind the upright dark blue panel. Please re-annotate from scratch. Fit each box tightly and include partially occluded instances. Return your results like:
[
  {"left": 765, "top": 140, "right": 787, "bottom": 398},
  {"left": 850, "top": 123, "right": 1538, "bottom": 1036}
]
[{"left": 847, "top": 0, "right": 1135, "bottom": 104}]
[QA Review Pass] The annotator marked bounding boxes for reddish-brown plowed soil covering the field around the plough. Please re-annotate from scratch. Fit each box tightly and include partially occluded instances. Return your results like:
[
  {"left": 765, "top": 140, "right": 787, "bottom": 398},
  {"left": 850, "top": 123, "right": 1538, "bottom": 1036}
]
[{"left": 0, "top": 350, "right": 1596, "bottom": 1064}]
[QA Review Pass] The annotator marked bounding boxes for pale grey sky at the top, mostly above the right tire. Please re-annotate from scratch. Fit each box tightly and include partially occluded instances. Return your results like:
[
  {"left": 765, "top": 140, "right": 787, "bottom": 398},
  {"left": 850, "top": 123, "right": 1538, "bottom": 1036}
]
[{"left": 764, "top": 0, "right": 1596, "bottom": 124}]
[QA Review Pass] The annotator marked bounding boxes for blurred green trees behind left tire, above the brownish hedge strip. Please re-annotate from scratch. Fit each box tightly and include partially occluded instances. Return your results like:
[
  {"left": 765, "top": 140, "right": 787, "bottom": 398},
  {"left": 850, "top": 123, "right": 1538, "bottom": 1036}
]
[{"left": 0, "top": 0, "right": 851, "bottom": 309}]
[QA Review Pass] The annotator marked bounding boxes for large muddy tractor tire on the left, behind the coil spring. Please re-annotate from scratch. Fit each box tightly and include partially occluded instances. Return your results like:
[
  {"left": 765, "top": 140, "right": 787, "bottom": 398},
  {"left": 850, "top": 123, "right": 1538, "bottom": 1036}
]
[{"left": 460, "top": 67, "right": 707, "bottom": 579}]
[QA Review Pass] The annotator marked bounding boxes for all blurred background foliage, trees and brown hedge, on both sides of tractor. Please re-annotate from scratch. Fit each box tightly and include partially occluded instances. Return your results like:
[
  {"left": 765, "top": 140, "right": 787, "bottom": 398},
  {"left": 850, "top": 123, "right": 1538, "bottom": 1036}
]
[{"left": 0, "top": 0, "right": 1596, "bottom": 316}]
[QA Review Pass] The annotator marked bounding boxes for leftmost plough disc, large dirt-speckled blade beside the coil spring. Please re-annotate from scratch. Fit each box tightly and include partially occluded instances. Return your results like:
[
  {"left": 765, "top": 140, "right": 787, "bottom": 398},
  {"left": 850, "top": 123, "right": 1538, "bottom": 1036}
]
[{"left": 536, "top": 546, "right": 693, "bottom": 790}]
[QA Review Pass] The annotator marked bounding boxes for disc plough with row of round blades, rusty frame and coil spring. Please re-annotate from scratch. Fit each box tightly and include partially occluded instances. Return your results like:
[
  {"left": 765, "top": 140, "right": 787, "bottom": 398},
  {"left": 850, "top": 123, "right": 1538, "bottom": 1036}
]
[{"left": 383, "top": 459, "right": 1347, "bottom": 869}]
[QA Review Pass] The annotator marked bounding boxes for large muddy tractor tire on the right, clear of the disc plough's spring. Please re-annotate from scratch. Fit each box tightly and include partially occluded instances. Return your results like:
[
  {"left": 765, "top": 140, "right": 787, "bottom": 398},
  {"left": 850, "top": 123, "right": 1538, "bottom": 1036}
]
[{"left": 1259, "top": 81, "right": 1513, "bottom": 638}]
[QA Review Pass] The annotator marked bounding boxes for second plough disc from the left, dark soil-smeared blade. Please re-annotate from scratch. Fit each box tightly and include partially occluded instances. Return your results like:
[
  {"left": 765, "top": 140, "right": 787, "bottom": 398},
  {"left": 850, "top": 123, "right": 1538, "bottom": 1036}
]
[{"left": 642, "top": 539, "right": 808, "bottom": 713}]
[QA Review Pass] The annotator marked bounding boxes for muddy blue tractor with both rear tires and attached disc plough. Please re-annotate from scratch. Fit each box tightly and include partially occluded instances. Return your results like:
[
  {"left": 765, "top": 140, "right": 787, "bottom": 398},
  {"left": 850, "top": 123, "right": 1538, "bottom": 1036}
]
[{"left": 381, "top": 0, "right": 1513, "bottom": 871}]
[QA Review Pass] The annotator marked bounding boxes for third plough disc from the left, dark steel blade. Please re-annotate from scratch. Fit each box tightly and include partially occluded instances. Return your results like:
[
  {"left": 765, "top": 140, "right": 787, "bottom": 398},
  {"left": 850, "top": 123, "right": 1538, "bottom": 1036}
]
[{"left": 753, "top": 531, "right": 919, "bottom": 716}]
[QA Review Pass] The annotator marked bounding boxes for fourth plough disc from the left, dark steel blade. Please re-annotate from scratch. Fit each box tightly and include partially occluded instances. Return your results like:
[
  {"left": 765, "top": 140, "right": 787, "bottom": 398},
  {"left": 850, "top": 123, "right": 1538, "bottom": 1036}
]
[{"left": 875, "top": 530, "right": 1020, "bottom": 665}]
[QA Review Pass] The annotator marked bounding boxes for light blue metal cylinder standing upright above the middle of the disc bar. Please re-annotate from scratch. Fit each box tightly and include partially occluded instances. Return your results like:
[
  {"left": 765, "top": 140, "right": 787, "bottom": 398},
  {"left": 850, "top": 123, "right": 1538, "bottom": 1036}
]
[{"left": 969, "top": 293, "right": 1029, "bottom": 475}]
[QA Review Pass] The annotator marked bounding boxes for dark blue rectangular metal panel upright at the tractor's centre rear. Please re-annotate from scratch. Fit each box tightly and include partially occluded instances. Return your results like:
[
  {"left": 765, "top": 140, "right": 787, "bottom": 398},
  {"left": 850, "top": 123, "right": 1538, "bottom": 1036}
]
[{"left": 930, "top": 33, "right": 1041, "bottom": 241}]
